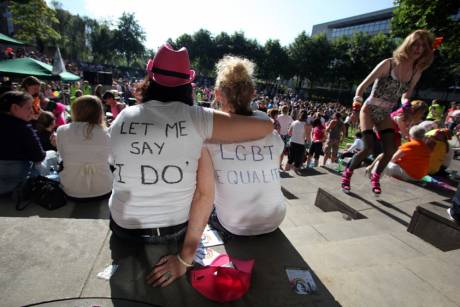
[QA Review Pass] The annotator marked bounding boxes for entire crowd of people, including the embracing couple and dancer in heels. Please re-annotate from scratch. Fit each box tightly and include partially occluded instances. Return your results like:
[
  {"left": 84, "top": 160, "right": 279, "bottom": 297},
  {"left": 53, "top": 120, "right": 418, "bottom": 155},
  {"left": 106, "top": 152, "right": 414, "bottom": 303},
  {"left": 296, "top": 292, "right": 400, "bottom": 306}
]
[{"left": 0, "top": 30, "right": 460, "bottom": 286}]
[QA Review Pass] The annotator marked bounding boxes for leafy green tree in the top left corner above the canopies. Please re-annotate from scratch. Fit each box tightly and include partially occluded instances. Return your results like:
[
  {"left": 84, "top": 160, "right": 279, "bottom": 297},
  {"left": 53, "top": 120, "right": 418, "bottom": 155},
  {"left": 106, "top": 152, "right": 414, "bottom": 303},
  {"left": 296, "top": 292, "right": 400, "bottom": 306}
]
[{"left": 9, "top": 0, "right": 61, "bottom": 51}]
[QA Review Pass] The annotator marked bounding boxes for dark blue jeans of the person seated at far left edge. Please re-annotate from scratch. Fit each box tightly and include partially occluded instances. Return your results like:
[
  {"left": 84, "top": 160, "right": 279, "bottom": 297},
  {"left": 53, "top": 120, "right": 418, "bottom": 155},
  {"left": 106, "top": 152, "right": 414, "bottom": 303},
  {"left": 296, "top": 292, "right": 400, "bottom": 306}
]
[{"left": 0, "top": 160, "right": 34, "bottom": 194}]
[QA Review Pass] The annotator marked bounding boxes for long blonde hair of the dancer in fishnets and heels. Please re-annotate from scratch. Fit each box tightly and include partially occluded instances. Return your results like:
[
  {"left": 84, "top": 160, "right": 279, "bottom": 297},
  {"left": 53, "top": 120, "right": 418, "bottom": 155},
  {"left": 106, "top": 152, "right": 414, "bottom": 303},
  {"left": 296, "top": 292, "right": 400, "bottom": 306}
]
[{"left": 393, "top": 30, "right": 434, "bottom": 71}]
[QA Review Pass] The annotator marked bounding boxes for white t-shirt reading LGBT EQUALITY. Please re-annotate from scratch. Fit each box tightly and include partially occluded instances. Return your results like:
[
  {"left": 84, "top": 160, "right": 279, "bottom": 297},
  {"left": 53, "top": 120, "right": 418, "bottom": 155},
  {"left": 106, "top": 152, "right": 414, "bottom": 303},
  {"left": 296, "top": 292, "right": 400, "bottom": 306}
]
[{"left": 206, "top": 112, "right": 286, "bottom": 235}]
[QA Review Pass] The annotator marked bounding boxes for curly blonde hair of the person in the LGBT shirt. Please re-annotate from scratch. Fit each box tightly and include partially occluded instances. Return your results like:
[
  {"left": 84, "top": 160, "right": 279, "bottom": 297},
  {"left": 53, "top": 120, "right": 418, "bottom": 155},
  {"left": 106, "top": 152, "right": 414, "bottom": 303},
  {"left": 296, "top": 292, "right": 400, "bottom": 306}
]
[{"left": 215, "top": 55, "right": 255, "bottom": 115}]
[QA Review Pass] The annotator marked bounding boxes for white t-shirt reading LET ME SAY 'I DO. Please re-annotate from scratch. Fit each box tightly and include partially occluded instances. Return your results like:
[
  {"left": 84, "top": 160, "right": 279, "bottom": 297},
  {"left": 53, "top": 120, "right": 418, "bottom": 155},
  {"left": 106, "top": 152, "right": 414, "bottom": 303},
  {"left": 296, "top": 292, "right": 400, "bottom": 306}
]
[{"left": 109, "top": 100, "right": 213, "bottom": 229}]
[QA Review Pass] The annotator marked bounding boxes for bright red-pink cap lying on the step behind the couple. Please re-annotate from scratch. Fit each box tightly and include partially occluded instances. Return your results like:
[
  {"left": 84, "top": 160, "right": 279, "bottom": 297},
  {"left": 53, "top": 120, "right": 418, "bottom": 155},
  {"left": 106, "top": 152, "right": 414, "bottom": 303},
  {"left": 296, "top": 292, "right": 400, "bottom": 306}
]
[{"left": 191, "top": 255, "right": 254, "bottom": 303}]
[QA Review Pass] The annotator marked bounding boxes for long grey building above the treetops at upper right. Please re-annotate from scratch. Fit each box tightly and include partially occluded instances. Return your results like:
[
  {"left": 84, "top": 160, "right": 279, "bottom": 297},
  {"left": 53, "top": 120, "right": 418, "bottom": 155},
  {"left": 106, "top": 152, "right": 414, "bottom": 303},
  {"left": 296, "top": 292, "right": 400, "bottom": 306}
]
[{"left": 311, "top": 8, "right": 394, "bottom": 40}]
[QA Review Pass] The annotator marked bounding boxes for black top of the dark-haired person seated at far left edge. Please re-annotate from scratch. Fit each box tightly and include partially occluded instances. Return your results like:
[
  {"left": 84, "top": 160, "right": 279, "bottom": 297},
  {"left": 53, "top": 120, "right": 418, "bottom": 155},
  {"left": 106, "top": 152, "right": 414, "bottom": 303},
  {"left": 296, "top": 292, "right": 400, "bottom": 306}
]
[{"left": 0, "top": 113, "right": 46, "bottom": 162}]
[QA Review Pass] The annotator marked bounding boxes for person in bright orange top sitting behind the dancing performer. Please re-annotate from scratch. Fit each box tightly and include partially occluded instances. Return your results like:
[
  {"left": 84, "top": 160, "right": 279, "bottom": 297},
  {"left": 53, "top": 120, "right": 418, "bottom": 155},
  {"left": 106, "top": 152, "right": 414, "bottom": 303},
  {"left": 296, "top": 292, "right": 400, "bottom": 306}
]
[{"left": 366, "top": 126, "right": 432, "bottom": 181}]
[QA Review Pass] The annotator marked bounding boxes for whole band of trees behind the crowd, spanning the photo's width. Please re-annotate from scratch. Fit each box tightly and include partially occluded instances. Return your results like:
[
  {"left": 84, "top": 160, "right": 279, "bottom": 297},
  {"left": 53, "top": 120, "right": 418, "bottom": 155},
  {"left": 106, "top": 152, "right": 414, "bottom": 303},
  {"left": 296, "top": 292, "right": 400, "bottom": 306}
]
[{"left": 9, "top": 0, "right": 460, "bottom": 95}]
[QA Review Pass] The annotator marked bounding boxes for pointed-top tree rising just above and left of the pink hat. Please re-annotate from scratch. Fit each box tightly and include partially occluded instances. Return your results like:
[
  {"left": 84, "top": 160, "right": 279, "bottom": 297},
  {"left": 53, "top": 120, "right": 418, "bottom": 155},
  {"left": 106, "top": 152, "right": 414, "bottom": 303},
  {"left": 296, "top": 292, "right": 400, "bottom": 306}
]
[{"left": 114, "top": 12, "right": 145, "bottom": 66}]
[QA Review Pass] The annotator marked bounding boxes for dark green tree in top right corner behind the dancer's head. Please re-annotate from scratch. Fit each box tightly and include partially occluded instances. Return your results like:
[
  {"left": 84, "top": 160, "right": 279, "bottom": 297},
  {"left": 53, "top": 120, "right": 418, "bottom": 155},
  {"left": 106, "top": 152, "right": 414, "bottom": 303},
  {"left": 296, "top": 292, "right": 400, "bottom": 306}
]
[{"left": 391, "top": 0, "right": 460, "bottom": 88}]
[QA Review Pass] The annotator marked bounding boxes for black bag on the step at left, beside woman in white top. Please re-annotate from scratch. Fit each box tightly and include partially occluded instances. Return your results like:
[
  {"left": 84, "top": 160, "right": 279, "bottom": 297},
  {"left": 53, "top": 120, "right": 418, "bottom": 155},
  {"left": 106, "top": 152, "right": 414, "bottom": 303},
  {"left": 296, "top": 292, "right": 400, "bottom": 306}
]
[{"left": 14, "top": 176, "right": 67, "bottom": 211}]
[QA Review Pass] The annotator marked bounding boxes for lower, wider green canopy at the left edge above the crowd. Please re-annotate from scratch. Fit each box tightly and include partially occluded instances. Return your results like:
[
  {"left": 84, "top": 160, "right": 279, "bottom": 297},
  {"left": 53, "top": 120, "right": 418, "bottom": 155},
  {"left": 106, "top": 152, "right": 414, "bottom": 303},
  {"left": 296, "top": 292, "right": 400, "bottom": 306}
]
[{"left": 0, "top": 58, "right": 80, "bottom": 81}]
